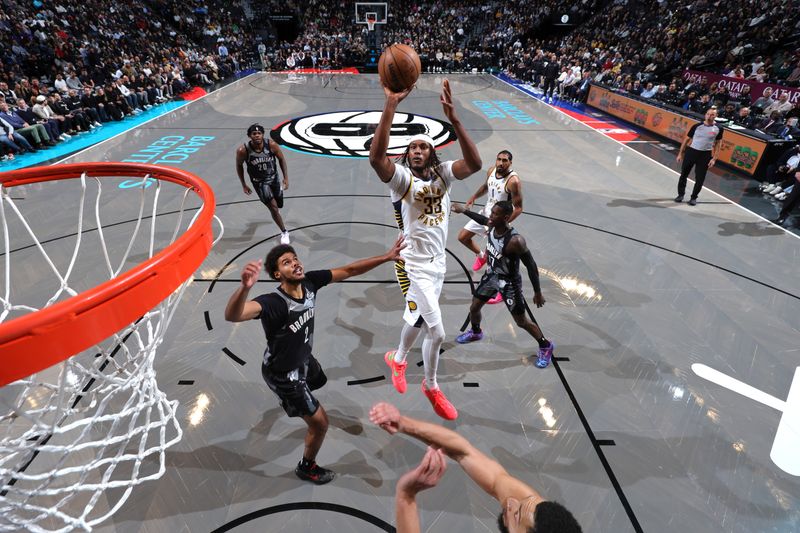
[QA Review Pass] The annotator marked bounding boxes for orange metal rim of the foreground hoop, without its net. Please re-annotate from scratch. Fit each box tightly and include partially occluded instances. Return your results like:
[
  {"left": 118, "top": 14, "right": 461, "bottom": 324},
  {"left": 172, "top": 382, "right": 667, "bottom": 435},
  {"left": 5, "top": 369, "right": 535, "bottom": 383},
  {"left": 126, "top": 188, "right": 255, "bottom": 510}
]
[{"left": 0, "top": 163, "right": 215, "bottom": 386}]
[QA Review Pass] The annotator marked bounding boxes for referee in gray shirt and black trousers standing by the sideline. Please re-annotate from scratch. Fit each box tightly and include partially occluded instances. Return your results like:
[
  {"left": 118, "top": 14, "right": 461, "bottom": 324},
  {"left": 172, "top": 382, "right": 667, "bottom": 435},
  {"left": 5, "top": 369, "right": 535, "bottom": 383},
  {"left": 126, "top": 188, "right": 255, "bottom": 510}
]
[{"left": 675, "top": 107, "right": 722, "bottom": 205}]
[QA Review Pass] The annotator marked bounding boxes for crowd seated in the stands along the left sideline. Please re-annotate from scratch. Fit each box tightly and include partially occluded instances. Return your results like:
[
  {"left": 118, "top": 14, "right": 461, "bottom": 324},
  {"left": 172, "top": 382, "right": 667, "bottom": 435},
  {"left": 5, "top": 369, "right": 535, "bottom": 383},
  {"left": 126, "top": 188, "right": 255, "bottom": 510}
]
[{"left": 0, "top": 0, "right": 251, "bottom": 159}]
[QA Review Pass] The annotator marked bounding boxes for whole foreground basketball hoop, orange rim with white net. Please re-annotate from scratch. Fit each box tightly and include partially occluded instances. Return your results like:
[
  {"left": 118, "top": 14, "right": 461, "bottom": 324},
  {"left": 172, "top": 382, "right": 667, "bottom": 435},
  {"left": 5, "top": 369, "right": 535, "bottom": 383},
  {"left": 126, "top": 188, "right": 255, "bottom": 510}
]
[{"left": 0, "top": 163, "right": 221, "bottom": 531}]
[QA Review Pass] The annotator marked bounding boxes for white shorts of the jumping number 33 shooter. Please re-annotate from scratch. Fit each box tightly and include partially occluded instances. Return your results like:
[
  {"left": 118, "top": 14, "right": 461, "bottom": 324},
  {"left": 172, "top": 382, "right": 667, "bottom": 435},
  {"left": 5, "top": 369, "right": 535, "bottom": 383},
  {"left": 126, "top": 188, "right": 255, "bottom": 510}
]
[{"left": 395, "top": 263, "right": 445, "bottom": 327}]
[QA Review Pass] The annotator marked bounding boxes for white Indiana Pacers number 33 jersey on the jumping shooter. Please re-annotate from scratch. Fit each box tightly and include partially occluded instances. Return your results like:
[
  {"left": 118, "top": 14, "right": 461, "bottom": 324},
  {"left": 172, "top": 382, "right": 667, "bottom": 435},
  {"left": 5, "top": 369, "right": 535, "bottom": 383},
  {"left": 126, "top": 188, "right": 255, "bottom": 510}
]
[{"left": 389, "top": 161, "right": 455, "bottom": 272}]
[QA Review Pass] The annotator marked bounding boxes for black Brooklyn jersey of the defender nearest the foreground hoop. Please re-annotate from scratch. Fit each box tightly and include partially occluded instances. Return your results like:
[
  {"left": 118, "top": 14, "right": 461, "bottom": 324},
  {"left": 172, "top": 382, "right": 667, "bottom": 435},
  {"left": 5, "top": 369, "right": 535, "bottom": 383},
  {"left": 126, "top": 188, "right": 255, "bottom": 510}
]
[{"left": 254, "top": 270, "right": 332, "bottom": 372}]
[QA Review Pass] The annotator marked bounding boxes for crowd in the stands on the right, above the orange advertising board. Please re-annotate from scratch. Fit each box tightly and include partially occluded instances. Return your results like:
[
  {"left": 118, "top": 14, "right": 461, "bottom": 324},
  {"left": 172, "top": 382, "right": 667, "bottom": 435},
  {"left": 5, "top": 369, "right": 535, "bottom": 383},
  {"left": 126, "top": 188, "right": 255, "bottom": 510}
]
[{"left": 488, "top": 0, "right": 800, "bottom": 139}]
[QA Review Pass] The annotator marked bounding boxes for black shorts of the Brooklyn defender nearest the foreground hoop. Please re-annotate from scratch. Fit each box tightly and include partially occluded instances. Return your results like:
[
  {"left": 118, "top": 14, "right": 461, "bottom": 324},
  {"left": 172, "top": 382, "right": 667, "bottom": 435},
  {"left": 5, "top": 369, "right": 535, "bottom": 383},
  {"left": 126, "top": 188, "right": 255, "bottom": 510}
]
[{"left": 261, "top": 357, "right": 328, "bottom": 417}]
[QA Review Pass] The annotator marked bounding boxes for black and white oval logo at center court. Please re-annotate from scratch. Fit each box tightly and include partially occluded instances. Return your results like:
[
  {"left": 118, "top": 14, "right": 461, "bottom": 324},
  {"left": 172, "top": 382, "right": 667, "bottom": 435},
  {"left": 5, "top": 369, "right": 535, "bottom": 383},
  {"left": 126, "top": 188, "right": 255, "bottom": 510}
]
[{"left": 270, "top": 111, "right": 456, "bottom": 157}]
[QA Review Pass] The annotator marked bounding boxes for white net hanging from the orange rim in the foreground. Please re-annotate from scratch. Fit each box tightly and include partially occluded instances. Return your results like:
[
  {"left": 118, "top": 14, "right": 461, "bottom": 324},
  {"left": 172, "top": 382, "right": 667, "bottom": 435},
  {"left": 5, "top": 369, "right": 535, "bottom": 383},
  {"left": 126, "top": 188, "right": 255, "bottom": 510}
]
[{"left": 0, "top": 175, "right": 221, "bottom": 531}]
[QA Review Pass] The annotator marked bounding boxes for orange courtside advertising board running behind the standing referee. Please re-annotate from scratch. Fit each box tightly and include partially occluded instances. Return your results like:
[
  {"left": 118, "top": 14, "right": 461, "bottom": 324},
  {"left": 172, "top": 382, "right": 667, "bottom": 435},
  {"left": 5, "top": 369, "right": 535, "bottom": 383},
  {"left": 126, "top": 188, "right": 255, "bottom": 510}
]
[{"left": 586, "top": 85, "right": 767, "bottom": 175}]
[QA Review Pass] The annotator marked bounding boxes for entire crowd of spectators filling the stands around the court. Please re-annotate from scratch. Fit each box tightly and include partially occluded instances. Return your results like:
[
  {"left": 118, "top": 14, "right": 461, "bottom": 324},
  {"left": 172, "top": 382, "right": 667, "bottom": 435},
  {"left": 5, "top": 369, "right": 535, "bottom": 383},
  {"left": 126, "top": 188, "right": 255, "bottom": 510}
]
[{"left": 0, "top": 0, "right": 800, "bottom": 160}]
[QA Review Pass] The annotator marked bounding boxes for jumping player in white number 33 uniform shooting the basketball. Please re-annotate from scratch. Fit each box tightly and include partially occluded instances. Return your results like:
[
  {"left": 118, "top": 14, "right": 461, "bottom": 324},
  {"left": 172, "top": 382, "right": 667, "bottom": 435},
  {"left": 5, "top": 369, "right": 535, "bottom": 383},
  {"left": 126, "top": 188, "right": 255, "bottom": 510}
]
[{"left": 369, "top": 79, "right": 481, "bottom": 420}]
